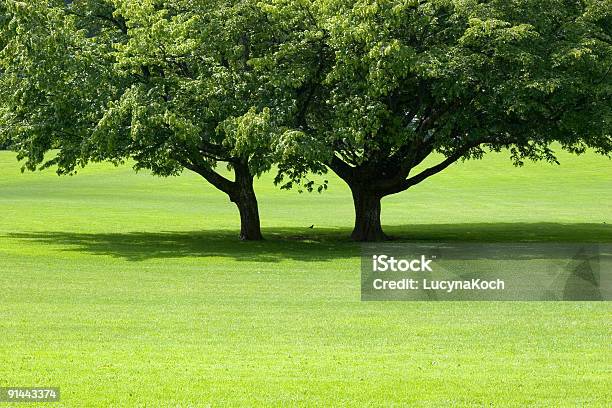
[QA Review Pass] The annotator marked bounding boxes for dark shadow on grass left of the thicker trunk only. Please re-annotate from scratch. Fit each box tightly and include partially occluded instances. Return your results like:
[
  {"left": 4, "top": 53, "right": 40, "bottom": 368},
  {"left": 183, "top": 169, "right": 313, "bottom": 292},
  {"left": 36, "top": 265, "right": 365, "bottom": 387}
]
[{"left": 6, "top": 229, "right": 359, "bottom": 262}]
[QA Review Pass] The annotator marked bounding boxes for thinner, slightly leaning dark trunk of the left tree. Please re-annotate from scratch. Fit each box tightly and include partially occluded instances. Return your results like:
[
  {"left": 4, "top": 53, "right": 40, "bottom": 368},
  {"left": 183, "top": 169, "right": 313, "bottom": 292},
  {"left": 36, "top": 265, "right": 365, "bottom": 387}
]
[{"left": 230, "top": 166, "right": 263, "bottom": 241}]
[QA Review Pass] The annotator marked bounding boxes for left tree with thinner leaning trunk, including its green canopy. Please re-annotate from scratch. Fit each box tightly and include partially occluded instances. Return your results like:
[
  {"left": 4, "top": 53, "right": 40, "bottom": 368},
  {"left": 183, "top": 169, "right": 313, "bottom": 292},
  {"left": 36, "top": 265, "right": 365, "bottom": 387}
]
[{"left": 0, "top": 0, "right": 283, "bottom": 240}]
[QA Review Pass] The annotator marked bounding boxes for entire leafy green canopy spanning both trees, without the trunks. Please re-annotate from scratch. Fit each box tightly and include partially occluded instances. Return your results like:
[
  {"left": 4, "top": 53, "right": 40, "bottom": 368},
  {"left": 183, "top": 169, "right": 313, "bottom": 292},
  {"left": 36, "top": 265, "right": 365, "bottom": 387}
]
[{"left": 0, "top": 0, "right": 612, "bottom": 193}]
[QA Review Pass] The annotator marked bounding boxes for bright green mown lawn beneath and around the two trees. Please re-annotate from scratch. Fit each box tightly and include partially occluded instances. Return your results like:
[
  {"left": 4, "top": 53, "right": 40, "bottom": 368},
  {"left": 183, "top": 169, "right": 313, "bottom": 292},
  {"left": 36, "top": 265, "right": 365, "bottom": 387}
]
[{"left": 0, "top": 152, "right": 612, "bottom": 407}]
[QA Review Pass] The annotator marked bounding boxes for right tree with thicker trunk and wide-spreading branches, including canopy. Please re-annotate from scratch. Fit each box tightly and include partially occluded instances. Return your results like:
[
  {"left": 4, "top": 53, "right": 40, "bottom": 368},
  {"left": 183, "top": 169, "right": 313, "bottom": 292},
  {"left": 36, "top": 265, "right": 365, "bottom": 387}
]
[{"left": 267, "top": 0, "right": 612, "bottom": 241}]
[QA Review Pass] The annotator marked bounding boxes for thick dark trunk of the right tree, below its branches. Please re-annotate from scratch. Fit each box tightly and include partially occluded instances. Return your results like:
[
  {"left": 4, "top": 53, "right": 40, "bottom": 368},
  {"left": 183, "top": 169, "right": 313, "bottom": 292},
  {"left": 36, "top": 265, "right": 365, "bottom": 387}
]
[{"left": 351, "top": 189, "right": 387, "bottom": 241}]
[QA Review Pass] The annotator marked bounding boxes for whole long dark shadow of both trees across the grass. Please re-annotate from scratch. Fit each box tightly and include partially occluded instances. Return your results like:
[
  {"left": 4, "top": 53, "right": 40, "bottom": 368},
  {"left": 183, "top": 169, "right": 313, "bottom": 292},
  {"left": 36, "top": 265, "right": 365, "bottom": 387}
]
[{"left": 4, "top": 223, "right": 612, "bottom": 262}]
